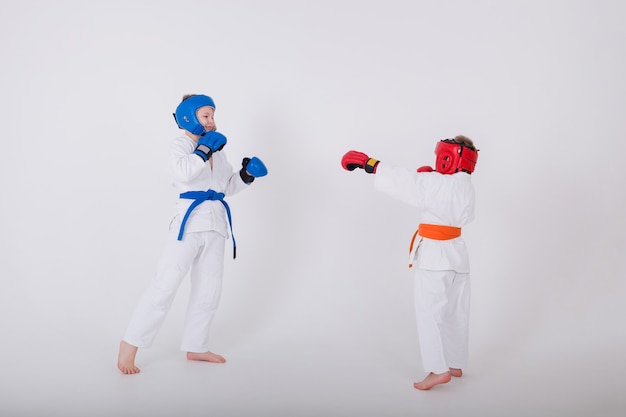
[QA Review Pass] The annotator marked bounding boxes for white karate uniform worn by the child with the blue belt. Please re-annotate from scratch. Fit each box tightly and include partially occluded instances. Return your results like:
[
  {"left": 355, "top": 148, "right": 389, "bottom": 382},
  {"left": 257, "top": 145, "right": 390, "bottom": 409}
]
[{"left": 123, "top": 135, "right": 247, "bottom": 352}]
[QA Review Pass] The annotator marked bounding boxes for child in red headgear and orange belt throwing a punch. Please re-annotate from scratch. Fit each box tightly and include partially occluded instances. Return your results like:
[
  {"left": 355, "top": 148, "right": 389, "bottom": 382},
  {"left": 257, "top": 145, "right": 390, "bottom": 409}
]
[{"left": 341, "top": 135, "right": 478, "bottom": 390}]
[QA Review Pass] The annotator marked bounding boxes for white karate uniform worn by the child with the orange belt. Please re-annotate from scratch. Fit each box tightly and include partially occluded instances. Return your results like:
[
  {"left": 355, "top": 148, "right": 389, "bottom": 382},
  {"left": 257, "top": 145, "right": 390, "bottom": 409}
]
[{"left": 374, "top": 163, "right": 475, "bottom": 374}]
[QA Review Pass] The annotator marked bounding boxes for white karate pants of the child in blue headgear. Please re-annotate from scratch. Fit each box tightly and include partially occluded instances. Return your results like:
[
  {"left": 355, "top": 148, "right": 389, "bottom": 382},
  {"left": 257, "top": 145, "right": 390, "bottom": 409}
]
[{"left": 123, "top": 227, "right": 226, "bottom": 352}]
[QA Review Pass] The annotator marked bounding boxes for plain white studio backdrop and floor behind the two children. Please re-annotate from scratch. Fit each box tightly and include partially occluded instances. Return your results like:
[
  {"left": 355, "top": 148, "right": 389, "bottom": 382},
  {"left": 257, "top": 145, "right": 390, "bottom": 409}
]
[{"left": 0, "top": 0, "right": 626, "bottom": 417}]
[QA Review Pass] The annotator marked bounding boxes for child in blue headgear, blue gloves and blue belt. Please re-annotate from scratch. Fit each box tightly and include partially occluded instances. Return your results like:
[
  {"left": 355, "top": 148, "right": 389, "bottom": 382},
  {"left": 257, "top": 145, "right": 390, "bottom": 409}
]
[{"left": 117, "top": 95, "right": 267, "bottom": 374}]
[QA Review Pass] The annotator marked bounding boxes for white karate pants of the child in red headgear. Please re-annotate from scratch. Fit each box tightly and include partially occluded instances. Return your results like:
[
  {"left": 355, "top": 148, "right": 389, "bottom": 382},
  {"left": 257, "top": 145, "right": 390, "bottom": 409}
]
[{"left": 414, "top": 269, "right": 470, "bottom": 374}]
